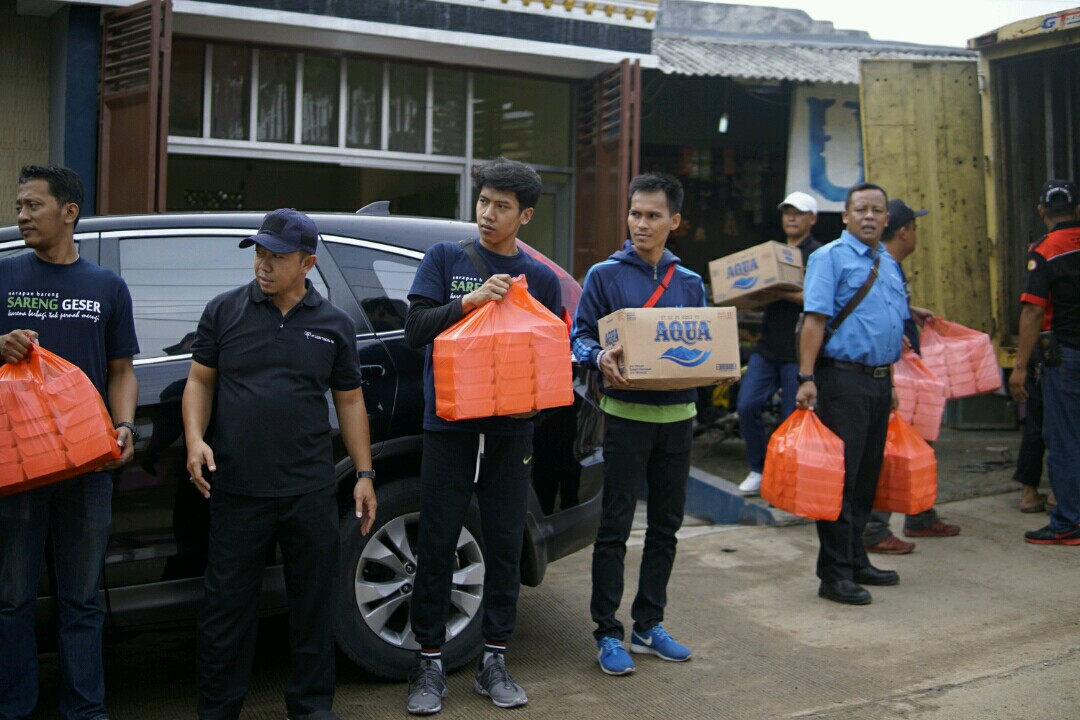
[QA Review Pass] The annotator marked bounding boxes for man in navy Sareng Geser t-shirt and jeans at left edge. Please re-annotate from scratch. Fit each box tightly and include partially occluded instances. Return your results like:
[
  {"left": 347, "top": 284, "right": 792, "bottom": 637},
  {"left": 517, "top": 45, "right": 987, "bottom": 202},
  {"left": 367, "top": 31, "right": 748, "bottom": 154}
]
[{"left": 0, "top": 165, "right": 138, "bottom": 720}]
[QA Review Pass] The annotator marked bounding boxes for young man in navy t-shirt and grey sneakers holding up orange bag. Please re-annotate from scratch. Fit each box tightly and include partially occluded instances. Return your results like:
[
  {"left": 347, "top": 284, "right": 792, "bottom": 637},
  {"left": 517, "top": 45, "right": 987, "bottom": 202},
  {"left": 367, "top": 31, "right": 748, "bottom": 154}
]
[{"left": 405, "top": 158, "right": 569, "bottom": 715}]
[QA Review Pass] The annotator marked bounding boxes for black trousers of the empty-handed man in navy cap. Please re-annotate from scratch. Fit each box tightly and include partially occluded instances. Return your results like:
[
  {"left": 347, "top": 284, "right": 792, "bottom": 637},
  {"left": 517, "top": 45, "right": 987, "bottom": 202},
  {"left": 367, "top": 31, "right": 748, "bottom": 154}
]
[{"left": 198, "top": 487, "right": 338, "bottom": 720}]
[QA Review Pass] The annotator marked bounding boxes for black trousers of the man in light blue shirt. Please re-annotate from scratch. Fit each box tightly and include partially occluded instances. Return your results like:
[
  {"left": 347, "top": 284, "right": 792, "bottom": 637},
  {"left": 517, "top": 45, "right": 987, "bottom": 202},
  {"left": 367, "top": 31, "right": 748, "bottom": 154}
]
[{"left": 815, "top": 367, "right": 892, "bottom": 582}]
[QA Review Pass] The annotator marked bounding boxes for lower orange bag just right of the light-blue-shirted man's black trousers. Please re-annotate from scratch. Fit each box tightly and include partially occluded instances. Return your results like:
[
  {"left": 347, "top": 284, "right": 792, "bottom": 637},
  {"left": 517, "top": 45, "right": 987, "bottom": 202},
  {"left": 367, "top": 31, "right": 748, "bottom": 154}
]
[{"left": 874, "top": 412, "right": 937, "bottom": 515}]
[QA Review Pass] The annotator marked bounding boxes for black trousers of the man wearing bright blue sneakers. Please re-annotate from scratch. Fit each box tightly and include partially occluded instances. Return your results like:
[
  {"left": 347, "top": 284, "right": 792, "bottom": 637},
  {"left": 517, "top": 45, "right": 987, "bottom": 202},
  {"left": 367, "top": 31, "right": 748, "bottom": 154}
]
[{"left": 590, "top": 416, "right": 693, "bottom": 640}]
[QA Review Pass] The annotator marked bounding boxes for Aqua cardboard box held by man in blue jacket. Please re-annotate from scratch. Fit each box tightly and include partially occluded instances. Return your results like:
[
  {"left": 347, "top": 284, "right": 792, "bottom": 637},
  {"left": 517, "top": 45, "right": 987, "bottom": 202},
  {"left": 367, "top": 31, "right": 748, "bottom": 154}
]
[{"left": 598, "top": 308, "right": 740, "bottom": 390}]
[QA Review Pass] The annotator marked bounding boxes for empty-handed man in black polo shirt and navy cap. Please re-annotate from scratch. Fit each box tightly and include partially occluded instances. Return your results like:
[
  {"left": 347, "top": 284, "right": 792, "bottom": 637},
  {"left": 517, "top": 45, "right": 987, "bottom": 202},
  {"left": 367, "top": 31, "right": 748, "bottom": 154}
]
[{"left": 184, "top": 209, "right": 376, "bottom": 720}]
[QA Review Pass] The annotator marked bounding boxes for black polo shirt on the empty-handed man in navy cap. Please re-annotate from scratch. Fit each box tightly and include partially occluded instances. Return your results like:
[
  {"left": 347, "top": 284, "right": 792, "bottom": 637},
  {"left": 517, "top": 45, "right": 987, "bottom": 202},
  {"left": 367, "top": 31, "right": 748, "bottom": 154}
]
[{"left": 191, "top": 281, "right": 360, "bottom": 498}]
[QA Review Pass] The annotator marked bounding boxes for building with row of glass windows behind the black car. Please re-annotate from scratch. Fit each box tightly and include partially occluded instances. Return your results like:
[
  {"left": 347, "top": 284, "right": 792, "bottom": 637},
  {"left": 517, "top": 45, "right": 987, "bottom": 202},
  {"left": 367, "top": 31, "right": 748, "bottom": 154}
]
[{"left": 0, "top": 0, "right": 659, "bottom": 272}]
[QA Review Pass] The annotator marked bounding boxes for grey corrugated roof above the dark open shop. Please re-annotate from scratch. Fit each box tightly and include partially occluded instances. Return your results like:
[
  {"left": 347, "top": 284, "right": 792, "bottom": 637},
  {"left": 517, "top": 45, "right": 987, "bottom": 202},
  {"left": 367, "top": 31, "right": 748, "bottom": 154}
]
[{"left": 652, "top": 35, "right": 977, "bottom": 84}]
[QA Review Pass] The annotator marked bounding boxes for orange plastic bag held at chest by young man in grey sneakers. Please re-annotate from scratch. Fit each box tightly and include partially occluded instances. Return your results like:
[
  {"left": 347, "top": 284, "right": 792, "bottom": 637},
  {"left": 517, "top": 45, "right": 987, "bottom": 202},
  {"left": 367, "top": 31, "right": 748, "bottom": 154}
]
[{"left": 433, "top": 275, "right": 573, "bottom": 420}]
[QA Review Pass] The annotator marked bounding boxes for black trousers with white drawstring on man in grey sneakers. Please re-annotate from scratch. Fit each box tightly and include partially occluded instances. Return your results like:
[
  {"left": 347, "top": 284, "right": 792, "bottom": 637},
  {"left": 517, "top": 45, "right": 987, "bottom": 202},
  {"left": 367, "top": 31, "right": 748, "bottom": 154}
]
[{"left": 409, "top": 431, "right": 532, "bottom": 649}]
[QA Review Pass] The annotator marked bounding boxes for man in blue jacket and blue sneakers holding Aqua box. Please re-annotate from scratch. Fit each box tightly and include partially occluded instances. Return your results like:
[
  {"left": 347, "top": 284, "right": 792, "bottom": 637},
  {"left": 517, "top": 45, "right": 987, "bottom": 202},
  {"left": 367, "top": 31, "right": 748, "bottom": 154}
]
[{"left": 571, "top": 175, "right": 705, "bottom": 675}]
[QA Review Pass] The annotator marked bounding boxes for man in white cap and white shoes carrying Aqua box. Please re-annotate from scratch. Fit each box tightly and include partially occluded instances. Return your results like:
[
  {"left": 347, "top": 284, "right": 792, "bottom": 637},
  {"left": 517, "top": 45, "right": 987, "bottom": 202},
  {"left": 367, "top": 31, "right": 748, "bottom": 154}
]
[{"left": 739, "top": 192, "right": 821, "bottom": 495}]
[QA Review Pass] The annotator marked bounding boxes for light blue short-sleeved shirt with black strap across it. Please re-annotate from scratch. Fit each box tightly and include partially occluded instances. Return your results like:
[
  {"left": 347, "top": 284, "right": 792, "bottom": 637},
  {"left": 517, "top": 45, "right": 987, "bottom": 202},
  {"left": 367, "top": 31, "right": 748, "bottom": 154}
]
[{"left": 802, "top": 230, "right": 909, "bottom": 366}]
